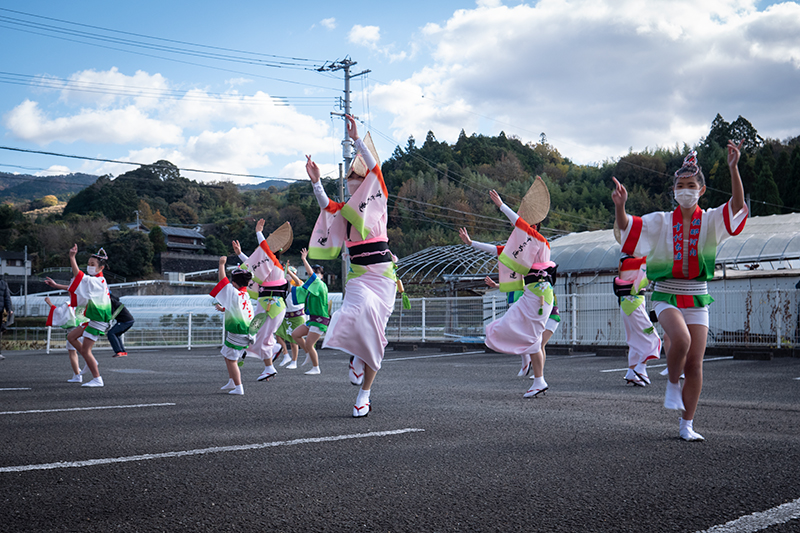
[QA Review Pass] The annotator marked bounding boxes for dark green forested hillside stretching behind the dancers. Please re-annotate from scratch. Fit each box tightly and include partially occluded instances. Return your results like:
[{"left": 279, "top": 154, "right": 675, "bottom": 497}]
[{"left": 0, "top": 115, "right": 800, "bottom": 279}]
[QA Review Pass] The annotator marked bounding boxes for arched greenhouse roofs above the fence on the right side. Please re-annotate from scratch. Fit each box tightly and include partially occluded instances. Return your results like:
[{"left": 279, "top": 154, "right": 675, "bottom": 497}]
[{"left": 397, "top": 213, "right": 800, "bottom": 283}]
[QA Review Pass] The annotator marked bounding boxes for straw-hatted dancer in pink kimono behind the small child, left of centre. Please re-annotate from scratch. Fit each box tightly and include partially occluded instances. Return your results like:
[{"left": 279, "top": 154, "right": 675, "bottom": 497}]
[{"left": 233, "top": 218, "right": 292, "bottom": 381}]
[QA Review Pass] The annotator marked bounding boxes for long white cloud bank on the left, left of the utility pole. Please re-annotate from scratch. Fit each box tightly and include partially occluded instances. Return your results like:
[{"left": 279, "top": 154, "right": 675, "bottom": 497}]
[{"left": 4, "top": 69, "right": 339, "bottom": 183}]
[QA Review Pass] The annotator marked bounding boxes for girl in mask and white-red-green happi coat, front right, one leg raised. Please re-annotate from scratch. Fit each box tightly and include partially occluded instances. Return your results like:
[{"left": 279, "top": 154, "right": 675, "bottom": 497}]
[{"left": 611, "top": 141, "right": 747, "bottom": 441}]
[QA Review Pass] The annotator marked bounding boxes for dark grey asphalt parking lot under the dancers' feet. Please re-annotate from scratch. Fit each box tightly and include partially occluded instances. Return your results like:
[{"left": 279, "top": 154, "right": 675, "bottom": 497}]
[{"left": 0, "top": 346, "right": 800, "bottom": 533}]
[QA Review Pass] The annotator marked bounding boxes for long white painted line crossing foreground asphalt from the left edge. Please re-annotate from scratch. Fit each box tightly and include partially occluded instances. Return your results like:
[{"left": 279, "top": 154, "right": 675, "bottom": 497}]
[{"left": 0, "top": 428, "right": 425, "bottom": 473}]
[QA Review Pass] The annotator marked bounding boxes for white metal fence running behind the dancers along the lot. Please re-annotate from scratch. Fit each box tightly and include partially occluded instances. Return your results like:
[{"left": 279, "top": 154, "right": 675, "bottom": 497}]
[{"left": 3, "top": 287, "right": 800, "bottom": 349}]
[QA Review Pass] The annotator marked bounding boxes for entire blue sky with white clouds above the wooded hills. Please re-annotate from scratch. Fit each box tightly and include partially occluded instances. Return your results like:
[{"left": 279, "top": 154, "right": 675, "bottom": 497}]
[{"left": 0, "top": 0, "right": 800, "bottom": 187}]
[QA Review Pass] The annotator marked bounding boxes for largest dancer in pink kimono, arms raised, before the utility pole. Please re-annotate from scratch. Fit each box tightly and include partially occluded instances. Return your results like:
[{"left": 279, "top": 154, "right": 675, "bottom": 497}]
[{"left": 306, "top": 116, "right": 397, "bottom": 417}]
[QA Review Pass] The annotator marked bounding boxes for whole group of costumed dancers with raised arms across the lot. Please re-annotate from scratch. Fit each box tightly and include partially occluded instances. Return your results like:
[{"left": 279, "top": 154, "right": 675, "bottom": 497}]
[{"left": 40, "top": 112, "right": 748, "bottom": 432}]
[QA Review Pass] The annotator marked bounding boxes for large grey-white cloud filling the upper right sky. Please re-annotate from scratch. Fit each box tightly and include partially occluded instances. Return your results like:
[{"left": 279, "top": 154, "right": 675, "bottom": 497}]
[{"left": 370, "top": 0, "right": 800, "bottom": 162}]
